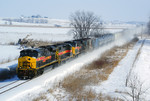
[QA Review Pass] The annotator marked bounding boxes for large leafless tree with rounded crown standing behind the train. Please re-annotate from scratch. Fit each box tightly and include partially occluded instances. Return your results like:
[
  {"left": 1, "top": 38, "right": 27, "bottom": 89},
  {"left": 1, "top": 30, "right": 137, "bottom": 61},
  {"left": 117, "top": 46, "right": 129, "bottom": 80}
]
[{"left": 70, "top": 11, "right": 102, "bottom": 39}]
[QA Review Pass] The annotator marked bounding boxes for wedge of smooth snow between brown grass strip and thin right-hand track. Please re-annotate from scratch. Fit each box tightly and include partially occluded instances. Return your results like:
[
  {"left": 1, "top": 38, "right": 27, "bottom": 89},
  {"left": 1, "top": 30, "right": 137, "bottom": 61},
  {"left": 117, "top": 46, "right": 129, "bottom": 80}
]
[{"left": 88, "top": 41, "right": 142, "bottom": 94}]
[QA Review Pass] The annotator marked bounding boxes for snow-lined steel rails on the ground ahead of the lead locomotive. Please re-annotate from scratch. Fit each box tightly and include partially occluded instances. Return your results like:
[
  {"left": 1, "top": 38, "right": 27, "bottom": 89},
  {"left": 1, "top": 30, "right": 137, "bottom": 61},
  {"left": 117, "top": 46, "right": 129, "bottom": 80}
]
[{"left": 0, "top": 80, "right": 30, "bottom": 95}]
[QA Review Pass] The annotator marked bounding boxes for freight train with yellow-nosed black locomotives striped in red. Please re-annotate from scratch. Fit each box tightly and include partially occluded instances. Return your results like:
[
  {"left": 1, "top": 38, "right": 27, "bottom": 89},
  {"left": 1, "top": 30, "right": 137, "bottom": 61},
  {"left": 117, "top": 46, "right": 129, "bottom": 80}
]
[{"left": 16, "top": 34, "right": 115, "bottom": 79}]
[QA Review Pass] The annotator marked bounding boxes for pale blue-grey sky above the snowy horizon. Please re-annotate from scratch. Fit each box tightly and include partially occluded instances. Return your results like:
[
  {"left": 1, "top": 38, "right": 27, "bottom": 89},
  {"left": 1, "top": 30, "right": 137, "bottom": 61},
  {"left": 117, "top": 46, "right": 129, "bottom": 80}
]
[{"left": 0, "top": 0, "right": 150, "bottom": 21}]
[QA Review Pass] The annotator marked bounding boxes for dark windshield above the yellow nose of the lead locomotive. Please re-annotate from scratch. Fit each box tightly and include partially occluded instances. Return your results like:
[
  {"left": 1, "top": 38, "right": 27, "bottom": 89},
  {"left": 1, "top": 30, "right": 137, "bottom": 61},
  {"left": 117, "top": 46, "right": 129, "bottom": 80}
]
[{"left": 20, "top": 49, "right": 38, "bottom": 58}]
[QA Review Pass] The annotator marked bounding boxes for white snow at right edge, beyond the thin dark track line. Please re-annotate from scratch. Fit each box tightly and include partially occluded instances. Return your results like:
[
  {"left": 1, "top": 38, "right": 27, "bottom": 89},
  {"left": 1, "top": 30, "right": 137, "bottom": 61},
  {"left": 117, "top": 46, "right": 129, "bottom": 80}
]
[{"left": 133, "top": 39, "right": 150, "bottom": 101}]
